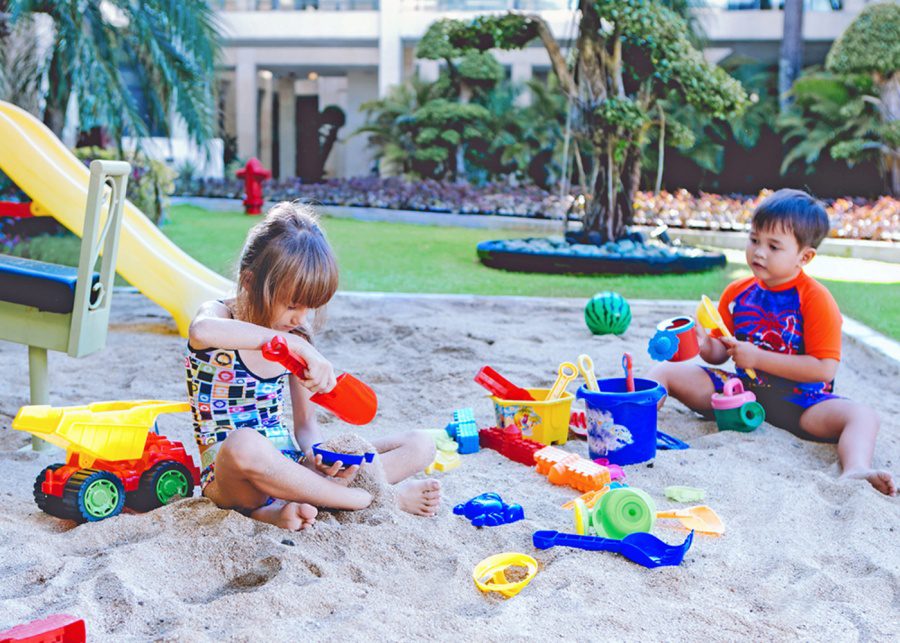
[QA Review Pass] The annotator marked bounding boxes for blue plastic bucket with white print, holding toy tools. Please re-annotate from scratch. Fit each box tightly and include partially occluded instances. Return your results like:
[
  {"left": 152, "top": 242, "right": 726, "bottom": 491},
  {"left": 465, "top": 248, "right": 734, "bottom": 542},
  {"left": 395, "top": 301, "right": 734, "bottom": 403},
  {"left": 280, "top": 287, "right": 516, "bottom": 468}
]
[{"left": 576, "top": 377, "right": 666, "bottom": 465}]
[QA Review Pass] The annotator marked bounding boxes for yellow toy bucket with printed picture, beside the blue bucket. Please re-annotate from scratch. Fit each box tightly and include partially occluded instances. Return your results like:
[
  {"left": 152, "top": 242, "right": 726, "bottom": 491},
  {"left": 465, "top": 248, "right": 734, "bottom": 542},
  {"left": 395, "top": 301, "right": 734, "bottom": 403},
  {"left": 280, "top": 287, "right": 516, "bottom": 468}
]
[{"left": 491, "top": 388, "right": 575, "bottom": 445}]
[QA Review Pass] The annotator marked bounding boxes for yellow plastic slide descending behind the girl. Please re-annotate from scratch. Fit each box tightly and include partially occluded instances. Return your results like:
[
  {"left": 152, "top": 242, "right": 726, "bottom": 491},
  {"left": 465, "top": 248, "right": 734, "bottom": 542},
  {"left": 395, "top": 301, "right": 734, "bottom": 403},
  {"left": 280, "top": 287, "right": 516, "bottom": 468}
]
[{"left": 0, "top": 101, "right": 233, "bottom": 336}]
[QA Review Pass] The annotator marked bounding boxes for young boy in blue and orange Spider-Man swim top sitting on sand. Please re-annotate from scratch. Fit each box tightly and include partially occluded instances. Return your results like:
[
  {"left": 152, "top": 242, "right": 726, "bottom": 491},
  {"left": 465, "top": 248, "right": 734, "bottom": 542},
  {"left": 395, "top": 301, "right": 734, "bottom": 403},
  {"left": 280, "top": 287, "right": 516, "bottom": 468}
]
[{"left": 648, "top": 190, "right": 897, "bottom": 496}]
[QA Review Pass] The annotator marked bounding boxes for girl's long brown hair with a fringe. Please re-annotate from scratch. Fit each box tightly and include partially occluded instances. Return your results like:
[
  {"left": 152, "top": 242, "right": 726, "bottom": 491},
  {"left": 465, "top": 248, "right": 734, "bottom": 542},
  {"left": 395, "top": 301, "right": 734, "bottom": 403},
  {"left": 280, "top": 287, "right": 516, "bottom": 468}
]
[{"left": 234, "top": 201, "right": 338, "bottom": 335}]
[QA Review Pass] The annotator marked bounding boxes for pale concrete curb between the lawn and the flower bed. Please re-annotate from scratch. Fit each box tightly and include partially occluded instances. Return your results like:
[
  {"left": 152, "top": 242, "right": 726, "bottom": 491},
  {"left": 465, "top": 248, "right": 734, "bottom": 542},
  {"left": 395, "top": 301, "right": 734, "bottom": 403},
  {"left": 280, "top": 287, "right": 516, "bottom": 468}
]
[{"left": 172, "top": 197, "right": 900, "bottom": 263}]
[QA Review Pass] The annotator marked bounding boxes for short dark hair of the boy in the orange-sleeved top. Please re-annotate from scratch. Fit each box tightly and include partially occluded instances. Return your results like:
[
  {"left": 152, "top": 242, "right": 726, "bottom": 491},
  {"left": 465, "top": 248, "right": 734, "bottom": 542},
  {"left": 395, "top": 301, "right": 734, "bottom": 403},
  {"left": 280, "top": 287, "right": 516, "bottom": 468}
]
[{"left": 751, "top": 189, "right": 829, "bottom": 248}]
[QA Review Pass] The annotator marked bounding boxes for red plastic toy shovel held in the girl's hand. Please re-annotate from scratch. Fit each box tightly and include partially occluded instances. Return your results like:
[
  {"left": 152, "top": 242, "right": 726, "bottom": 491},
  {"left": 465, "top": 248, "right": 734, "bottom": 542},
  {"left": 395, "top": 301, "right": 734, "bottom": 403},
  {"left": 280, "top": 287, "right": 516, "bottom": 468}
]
[{"left": 262, "top": 337, "right": 378, "bottom": 424}]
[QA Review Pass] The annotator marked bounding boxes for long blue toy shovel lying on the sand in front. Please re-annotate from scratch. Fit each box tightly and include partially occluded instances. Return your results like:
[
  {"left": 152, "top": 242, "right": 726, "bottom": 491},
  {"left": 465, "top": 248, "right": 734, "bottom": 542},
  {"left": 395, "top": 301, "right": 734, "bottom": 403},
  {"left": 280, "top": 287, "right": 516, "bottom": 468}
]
[{"left": 532, "top": 530, "right": 694, "bottom": 569}]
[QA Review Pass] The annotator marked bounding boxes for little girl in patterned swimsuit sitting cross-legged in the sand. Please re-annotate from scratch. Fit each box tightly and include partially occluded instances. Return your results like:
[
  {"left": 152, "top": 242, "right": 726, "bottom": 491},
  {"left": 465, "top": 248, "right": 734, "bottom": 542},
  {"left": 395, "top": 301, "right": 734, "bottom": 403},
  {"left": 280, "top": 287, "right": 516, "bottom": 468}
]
[{"left": 185, "top": 202, "right": 440, "bottom": 530}]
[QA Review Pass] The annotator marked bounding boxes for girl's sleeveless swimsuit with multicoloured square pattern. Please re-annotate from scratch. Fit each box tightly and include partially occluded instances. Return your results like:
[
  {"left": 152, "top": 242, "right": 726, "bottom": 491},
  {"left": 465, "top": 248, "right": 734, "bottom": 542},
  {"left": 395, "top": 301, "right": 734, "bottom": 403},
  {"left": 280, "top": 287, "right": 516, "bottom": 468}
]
[{"left": 184, "top": 344, "right": 303, "bottom": 490}]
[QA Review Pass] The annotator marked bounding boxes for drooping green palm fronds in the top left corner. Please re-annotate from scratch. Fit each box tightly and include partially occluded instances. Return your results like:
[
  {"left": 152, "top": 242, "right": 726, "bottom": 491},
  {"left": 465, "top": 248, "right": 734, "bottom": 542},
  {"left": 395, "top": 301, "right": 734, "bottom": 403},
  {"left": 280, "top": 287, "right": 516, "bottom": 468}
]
[{"left": 0, "top": 0, "right": 221, "bottom": 143}]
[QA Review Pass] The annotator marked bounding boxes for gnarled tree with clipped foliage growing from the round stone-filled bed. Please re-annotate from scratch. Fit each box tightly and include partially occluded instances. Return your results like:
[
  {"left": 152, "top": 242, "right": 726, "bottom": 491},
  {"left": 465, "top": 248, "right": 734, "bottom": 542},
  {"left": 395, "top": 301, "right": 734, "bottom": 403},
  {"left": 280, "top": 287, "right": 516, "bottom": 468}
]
[{"left": 419, "top": 0, "right": 748, "bottom": 240}]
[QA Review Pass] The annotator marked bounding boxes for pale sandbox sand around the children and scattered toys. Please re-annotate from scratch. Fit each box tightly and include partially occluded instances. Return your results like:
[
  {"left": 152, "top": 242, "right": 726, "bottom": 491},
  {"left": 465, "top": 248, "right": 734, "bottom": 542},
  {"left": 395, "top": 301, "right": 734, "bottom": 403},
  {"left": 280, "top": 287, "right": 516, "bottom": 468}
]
[{"left": 0, "top": 294, "right": 900, "bottom": 641}]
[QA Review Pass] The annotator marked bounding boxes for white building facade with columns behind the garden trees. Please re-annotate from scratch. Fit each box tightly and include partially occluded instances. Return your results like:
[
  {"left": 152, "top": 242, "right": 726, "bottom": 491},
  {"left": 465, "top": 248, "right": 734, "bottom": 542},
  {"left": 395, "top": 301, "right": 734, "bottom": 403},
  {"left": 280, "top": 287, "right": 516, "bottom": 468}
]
[{"left": 216, "top": 0, "right": 880, "bottom": 178}]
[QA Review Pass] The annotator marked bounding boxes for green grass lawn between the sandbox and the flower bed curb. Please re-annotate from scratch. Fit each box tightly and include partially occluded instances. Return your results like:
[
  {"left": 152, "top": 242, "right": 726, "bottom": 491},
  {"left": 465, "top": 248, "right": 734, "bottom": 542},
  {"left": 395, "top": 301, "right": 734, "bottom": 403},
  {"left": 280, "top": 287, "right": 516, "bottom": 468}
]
[{"left": 8, "top": 206, "right": 900, "bottom": 339}]
